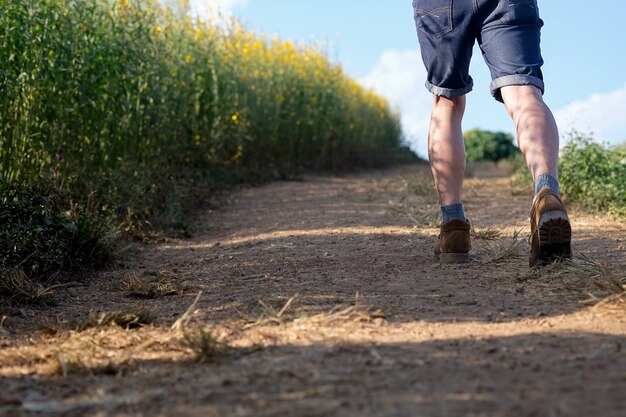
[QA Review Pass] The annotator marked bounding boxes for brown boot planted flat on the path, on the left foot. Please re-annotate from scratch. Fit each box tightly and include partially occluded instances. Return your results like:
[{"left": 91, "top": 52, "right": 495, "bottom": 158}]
[{"left": 435, "top": 220, "right": 472, "bottom": 264}]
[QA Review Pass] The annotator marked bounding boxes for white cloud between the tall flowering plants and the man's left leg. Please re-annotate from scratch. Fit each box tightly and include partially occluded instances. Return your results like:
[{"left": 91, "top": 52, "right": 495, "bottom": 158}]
[{"left": 359, "top": 50, "right": 432, "bottom": 157}]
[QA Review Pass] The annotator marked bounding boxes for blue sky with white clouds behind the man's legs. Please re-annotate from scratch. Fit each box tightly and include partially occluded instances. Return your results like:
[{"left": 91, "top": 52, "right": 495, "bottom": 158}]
[{"left": 191, "top": 0, "right": 626, "bottom": 155}]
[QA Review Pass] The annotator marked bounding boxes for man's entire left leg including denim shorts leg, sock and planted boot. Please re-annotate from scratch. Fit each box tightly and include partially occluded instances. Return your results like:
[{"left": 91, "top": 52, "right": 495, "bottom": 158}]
[{"left": 413, "top": 0, "right": 478, "bottom": 263}]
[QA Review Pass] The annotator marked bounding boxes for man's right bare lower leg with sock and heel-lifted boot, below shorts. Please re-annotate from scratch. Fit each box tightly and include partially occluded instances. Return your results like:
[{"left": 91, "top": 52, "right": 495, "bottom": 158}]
[{"left": 500, "top": 85, "right": 572, "bottom": 267}]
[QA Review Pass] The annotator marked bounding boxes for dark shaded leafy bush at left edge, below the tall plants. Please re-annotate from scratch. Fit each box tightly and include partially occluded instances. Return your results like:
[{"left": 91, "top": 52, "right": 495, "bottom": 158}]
[{"left": 0, "top": 182, "right": 111, "bottom": 279}]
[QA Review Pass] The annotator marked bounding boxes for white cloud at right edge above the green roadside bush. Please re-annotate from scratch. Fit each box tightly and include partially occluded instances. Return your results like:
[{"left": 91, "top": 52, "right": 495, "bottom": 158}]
[{"left": 554, "top": 85, "right": 626, "bottom": 145}]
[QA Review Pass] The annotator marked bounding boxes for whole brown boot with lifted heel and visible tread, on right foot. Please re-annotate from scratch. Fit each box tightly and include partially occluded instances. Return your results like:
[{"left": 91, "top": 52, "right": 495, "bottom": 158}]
[{"left": 529, "top": 188, "right": 572, "bottom": 268}]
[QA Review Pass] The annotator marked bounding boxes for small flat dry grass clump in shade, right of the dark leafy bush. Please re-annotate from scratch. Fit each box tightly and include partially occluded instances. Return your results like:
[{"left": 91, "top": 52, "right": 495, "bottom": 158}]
[{"left": 117, "top": 271, "right": 184, "bottom": 300}]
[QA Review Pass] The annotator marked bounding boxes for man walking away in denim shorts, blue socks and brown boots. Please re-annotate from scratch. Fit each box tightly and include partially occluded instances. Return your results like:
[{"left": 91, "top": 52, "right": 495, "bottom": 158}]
[{"left": 413, "top": 0, "right": 572, "bottom": 267}]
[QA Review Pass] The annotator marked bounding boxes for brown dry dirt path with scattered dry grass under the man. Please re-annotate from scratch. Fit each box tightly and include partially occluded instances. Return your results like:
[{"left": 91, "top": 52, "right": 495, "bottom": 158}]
[{"left": 0, "top": 167, "right": 626, "bottom": 417}]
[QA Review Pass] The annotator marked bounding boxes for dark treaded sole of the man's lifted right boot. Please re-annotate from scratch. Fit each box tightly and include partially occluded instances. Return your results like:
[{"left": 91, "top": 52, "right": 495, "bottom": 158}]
[{"left": 535, "top": 210, "right": 572, "bottom": 266}]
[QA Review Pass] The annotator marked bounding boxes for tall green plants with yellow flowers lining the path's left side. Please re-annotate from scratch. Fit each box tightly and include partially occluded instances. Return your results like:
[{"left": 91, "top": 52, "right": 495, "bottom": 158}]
[{"left": 0, "top": 0, "right": 412, "bottom": 286}]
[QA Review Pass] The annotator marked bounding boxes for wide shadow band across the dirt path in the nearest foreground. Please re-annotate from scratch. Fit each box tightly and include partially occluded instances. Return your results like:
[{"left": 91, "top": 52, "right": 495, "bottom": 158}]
[{"left": 0, "top": 333, "right": 626, "bottom": 417}]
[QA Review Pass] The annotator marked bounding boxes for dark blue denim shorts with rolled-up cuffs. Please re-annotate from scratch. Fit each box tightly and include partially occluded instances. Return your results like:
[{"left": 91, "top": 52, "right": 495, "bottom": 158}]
[{"left": 413, "top": 0, "right": 544, "bottom": 101}]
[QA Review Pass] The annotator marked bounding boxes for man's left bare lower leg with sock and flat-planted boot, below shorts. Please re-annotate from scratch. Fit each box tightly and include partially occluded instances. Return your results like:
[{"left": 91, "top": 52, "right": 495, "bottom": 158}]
[{"left": 428, "top": 96, "right": 471, "bottom": 263}]
